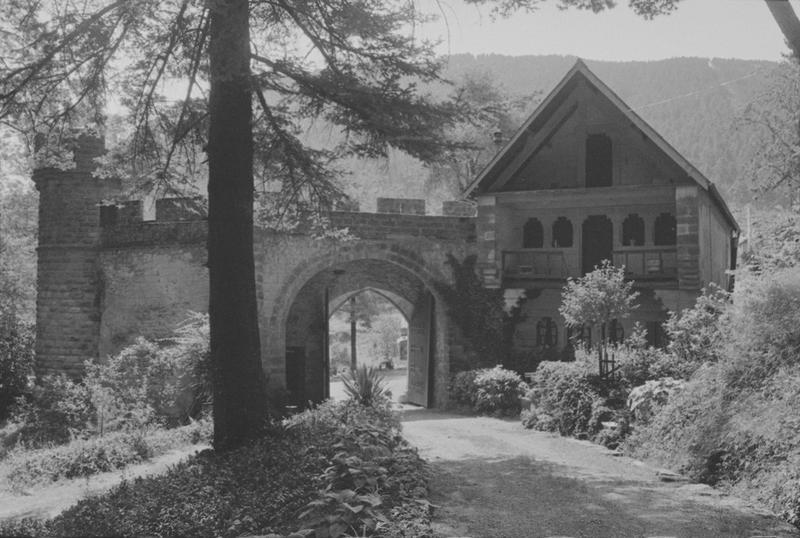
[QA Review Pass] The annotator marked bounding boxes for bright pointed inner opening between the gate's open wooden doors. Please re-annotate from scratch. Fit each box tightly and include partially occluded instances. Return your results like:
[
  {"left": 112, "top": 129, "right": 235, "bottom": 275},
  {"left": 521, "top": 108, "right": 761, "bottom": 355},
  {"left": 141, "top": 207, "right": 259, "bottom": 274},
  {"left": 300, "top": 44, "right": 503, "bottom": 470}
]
[{"left": 328, "top": 288, "right": 408, "bottom": 402}]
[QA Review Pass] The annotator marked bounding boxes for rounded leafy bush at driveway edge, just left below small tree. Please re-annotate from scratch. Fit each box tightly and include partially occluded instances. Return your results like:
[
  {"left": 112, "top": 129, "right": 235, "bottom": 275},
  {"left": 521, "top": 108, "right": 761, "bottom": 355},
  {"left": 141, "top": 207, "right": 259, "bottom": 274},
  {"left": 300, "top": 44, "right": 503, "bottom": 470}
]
[{"left": 522, "top": 356, "right": 601, "bottom": 436}]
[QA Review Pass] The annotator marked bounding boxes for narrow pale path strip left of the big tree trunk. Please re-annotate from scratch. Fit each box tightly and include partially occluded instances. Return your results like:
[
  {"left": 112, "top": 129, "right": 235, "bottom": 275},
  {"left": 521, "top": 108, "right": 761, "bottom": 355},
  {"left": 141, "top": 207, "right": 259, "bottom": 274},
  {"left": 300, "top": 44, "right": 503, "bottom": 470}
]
[{"left": 0, "top": 445, "right": 209, "bottom": 521}]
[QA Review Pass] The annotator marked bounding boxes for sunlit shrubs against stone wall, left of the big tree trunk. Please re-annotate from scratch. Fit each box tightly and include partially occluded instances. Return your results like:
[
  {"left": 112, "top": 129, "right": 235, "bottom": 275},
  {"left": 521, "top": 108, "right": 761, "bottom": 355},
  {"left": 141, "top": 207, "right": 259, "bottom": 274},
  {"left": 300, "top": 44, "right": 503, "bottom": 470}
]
[{"left": 14, "top": 316, "right": 210, "bottom": 447}]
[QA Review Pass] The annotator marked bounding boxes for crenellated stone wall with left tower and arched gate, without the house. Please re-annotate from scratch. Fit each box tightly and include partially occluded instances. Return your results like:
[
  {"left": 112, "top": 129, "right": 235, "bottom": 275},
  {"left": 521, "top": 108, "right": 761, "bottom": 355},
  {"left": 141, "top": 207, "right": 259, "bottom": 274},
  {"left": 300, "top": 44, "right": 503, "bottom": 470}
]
[{"left": 34, "top": 132, "right": 476, "bottom": 405}]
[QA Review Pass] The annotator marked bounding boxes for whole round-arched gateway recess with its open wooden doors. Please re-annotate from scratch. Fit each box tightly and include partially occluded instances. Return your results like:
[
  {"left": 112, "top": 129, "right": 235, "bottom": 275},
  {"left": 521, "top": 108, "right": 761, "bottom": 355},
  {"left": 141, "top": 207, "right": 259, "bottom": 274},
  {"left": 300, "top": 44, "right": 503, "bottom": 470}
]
[{"left": 283, "top": 258, "right": 434, "bottom": 407}]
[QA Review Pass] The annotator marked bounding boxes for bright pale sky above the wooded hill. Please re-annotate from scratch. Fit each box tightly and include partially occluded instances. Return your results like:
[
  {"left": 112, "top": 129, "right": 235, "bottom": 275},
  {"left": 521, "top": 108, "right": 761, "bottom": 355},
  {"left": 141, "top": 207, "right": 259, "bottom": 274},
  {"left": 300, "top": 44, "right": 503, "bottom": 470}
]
[{"left": 422, "top": 0, "right": 800, "bottom": 61}]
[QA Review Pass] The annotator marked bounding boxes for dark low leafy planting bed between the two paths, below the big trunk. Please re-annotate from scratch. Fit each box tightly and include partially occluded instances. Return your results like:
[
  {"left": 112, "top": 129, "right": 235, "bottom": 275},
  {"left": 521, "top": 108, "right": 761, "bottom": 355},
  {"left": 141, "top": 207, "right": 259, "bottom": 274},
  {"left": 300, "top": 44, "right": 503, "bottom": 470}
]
[{"left": 15, "top": 401, "right": 431, "bottom": 538}]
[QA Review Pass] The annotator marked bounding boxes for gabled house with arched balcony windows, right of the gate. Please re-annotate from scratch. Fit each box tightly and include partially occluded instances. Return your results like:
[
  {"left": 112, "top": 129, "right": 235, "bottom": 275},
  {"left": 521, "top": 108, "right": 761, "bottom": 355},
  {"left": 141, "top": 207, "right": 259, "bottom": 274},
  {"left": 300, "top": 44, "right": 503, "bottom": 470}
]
[{"left": 467, "top": 60, "right": 739, "bottom": 350}]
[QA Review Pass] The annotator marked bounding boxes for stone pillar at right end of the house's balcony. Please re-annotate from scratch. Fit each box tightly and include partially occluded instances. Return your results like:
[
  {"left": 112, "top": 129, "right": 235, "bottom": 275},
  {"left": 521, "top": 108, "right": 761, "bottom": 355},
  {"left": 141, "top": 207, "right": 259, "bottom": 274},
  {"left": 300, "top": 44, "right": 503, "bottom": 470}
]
[{"left": 675, "top": 185, "right": 700, "bottom": 289}]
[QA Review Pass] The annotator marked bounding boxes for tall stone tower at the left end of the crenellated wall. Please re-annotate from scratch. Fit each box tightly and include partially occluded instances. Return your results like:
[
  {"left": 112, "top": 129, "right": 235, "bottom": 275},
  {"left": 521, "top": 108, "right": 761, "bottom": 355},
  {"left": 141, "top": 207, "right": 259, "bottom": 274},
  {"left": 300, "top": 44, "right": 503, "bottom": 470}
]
[{"left": 33, "top": 135, "right": 119, "bottom": 378}]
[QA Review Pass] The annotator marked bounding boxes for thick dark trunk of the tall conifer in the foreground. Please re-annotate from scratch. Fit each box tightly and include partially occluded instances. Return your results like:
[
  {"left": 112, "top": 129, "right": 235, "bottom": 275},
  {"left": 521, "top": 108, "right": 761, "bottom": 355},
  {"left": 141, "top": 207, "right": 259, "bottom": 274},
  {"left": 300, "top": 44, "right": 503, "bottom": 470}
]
[{"left": 208, "top": 0, "right": 267, "bottom": 450}]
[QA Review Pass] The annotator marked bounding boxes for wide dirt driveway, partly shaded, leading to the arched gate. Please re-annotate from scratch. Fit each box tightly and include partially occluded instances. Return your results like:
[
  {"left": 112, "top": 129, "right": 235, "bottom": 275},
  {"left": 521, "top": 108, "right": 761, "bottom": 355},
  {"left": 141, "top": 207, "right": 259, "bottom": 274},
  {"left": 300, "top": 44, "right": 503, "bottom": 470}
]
[{"left": 403, "top": 410, "right": 800, "bottom": 538}]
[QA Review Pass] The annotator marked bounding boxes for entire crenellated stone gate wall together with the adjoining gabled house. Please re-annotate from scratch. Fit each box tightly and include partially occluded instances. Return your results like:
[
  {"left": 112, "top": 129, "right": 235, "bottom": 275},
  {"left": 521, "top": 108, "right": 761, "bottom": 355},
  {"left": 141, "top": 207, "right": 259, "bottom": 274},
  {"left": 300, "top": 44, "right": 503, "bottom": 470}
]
[{"left": 34, "top": 61, "right": 739, "bottom": 405}]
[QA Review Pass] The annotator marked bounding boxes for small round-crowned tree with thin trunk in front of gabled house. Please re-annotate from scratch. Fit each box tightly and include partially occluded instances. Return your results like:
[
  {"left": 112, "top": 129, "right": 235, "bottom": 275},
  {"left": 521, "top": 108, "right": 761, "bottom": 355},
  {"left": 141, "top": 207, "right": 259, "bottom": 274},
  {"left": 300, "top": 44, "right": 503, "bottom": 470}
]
[{"left": 558, "top": 260, "right": 639, "bottom": 376}]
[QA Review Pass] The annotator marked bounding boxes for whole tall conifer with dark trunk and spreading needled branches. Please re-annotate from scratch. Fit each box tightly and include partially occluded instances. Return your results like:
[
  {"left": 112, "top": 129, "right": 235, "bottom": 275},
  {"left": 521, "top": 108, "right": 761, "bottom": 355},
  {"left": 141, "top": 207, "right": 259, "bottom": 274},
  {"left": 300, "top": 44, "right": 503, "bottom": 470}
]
[{"left": 0, "top": 0, "right": 466, "bottom": 448}]
